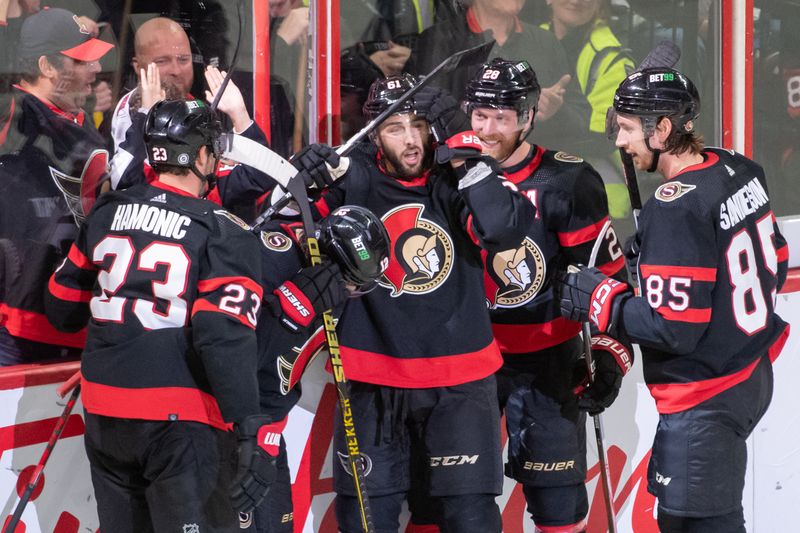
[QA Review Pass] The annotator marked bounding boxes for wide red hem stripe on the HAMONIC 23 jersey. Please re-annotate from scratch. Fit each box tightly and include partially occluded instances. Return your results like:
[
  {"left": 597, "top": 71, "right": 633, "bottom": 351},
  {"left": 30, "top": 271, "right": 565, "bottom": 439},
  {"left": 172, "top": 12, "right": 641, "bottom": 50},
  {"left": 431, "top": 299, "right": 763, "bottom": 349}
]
[{"left": 81, "top": 377, "right": 231, "bottom": 431}]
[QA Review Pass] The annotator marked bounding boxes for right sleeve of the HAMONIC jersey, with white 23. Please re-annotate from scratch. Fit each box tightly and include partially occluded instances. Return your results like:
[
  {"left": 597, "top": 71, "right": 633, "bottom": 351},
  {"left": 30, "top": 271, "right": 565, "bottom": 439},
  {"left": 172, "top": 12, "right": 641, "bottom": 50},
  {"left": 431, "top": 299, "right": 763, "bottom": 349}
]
[{"left": 191, "top": 217, "right": 262, "bottom": 422}]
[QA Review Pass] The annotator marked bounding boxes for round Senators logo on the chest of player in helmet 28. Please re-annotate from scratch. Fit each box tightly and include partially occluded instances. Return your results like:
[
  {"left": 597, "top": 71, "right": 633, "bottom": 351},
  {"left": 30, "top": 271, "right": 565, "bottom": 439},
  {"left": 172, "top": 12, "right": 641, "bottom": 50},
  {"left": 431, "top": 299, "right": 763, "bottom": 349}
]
[{"left": 484, "top": 237, "right": 547, "bottom": 309}]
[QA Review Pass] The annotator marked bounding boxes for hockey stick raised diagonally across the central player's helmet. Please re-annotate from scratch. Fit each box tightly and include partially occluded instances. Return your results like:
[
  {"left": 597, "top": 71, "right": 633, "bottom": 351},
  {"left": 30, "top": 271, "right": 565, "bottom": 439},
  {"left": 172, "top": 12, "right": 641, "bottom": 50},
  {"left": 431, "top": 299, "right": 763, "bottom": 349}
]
[{"left": 255, "top": 40, "right": 495, "bottom": 222}]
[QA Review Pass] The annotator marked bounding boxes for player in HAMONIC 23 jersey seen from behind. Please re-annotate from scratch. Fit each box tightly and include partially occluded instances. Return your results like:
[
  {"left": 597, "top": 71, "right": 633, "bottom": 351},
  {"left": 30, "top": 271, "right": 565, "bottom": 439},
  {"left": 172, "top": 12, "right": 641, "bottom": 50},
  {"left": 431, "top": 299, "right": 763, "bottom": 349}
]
[{"left": 42, "top": 100, "right": 342, "bottom": 533}]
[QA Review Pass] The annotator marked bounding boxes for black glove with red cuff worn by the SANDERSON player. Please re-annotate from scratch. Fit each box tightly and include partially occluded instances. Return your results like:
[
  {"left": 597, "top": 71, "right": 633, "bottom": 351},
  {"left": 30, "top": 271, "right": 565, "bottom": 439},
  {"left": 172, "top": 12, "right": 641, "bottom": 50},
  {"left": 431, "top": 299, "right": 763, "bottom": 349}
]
[{"left": 556, "top": 265, "right": 628, "bottom": 333}]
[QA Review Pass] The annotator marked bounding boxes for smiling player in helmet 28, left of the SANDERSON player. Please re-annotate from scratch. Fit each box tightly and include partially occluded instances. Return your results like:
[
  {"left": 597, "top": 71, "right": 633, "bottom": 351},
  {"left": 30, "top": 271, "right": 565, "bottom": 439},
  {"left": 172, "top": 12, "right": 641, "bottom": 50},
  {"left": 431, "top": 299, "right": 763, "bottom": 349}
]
[{"left": 464, "top": 58, "right": 632, "bottom": 533}]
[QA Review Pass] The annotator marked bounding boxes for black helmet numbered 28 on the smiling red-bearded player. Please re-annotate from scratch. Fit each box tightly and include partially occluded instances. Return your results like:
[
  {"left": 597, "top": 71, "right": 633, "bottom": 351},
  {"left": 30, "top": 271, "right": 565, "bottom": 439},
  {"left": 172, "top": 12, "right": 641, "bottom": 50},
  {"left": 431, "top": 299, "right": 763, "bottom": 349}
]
[{"left": 464, "top": 57, "right": 542, "bottom": 122}]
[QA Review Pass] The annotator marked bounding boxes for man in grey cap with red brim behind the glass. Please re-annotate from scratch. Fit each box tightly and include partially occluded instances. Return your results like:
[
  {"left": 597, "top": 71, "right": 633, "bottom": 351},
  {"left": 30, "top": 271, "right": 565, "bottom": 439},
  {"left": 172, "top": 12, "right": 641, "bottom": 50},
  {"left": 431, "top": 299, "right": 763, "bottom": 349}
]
[{"left": 0, "top": 9, "right": 113, "bottom": 365}]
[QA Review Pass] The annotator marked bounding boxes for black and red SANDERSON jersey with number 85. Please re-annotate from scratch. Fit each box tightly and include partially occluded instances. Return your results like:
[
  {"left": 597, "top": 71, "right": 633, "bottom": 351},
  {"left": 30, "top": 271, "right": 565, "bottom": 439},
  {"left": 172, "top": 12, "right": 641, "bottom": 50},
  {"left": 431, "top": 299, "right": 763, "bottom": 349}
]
[{"left": 622, "top": 148, "right": 788, "bottom": 413}]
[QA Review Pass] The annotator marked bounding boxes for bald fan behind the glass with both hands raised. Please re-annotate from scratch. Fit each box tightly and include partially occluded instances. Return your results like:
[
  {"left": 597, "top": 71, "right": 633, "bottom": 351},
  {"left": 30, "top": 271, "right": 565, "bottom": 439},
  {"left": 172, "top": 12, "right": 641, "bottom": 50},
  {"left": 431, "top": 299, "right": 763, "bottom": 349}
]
[{"left": 111, "top": 17, "right": 275, "bottom": 218}]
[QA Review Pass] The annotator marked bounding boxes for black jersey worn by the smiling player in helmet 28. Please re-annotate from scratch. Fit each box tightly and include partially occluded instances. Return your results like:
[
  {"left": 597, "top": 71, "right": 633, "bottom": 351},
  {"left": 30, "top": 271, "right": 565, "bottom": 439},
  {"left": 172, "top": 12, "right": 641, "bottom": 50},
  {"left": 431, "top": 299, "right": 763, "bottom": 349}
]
[{"left": 482, "top": 146, "right": 626, "bottom": 354}]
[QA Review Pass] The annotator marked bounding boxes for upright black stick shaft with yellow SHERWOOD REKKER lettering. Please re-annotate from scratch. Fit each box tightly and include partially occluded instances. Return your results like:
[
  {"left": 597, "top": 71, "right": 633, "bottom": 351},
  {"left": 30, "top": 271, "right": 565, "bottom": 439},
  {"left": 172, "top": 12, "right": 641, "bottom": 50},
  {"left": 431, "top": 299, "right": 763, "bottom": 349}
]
[{"left": 287, "top": 179, "right": 375, "bottom": 533}]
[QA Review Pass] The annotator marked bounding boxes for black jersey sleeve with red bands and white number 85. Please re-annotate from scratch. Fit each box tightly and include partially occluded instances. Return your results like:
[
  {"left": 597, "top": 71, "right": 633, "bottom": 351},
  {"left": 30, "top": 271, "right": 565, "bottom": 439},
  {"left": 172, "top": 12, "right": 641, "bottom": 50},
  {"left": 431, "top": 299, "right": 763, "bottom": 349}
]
[{"left": 622, "top": 204, "right": 717, "bottom": 354}]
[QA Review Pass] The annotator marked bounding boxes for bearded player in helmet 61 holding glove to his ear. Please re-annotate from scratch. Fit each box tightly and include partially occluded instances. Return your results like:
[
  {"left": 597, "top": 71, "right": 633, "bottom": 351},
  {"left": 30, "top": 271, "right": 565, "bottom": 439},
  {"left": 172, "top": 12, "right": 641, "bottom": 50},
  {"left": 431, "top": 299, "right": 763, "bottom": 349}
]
[{"left": 290, "top": 75, "right": 535, "bottom": 533}]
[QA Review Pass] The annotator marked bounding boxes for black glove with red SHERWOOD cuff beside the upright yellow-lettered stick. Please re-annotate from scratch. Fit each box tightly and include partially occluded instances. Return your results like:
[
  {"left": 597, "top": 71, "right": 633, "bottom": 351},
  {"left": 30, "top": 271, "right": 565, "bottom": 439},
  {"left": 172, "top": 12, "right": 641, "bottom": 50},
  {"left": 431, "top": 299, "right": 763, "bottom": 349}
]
[{"left": 274, "top": 262, "right": 347, "bottom": 331}]
